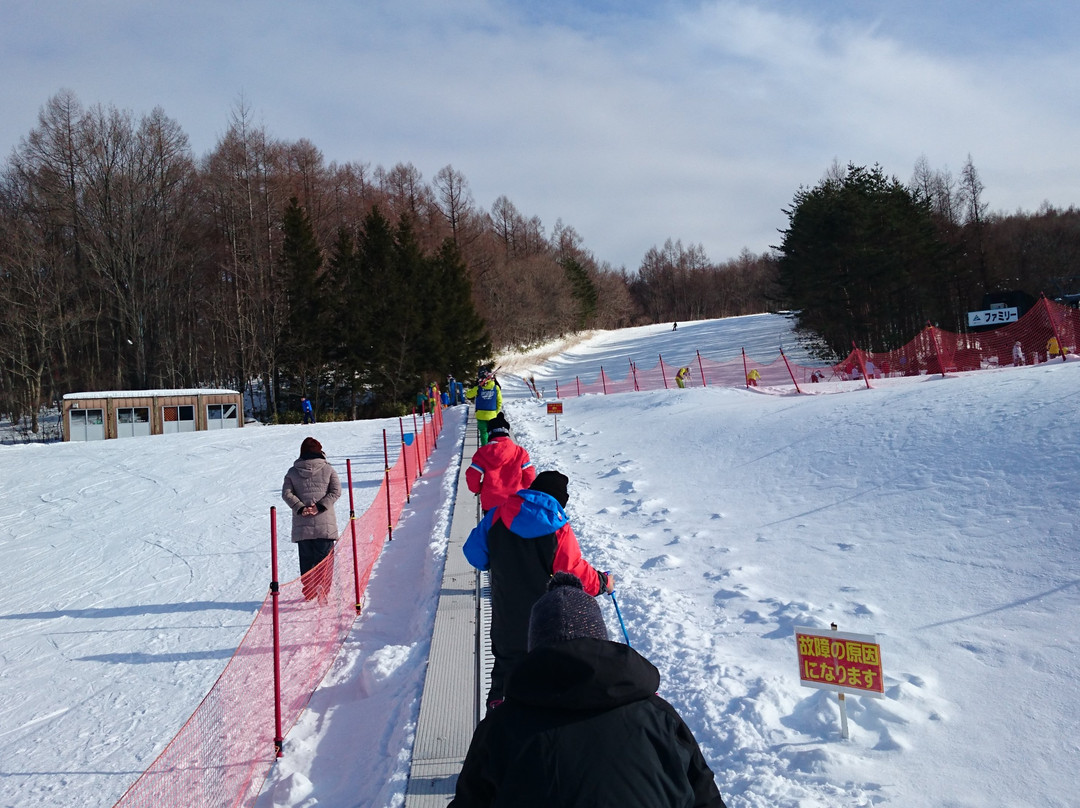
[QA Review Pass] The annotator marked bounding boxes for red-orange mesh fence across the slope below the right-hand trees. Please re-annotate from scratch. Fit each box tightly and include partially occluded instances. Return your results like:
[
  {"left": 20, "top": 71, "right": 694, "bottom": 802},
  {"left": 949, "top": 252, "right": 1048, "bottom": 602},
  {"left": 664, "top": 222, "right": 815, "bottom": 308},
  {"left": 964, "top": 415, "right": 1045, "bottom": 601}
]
[{"left": 555, "top": 298, "right": 1080, "bottom": 398}]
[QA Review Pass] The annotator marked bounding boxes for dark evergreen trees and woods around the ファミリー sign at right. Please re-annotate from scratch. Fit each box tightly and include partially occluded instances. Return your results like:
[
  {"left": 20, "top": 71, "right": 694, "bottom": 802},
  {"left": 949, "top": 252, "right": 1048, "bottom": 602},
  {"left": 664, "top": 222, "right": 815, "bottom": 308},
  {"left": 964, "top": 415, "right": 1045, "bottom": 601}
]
[{"left": 777, "top": 156, "right": 1080, "bottom": 360}]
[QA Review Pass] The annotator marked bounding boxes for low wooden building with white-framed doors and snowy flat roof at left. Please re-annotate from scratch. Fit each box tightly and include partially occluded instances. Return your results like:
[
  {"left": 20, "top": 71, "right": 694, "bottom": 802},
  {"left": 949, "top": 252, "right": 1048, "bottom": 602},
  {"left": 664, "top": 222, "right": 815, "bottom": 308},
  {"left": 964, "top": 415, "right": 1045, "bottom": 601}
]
[{"left": 63, "top": 390, "right": 244, "bottom": 441}]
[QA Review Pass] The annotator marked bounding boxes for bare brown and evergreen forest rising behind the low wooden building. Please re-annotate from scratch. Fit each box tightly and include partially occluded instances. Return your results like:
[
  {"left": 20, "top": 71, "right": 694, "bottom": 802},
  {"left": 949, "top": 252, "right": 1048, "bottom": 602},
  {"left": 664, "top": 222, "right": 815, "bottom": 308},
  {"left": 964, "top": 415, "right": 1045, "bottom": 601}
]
[{"left": 0, "top": 91, "right": 777, "bottom": 418}]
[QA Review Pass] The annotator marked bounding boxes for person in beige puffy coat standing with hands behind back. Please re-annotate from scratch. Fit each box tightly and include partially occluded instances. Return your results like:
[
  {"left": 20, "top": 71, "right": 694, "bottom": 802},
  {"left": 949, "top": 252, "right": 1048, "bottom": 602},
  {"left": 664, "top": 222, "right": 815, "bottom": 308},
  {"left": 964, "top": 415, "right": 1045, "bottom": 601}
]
[{"left": 281, "top": 437, "right": 341, "bottom": 602}]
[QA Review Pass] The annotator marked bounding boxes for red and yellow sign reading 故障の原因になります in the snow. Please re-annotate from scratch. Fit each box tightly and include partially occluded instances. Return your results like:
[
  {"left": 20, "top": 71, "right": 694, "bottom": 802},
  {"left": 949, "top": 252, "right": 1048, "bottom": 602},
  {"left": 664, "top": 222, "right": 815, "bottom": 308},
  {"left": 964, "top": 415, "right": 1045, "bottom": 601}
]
[{"left": 795, "top": 625, "right": 885, "bottom": 698}]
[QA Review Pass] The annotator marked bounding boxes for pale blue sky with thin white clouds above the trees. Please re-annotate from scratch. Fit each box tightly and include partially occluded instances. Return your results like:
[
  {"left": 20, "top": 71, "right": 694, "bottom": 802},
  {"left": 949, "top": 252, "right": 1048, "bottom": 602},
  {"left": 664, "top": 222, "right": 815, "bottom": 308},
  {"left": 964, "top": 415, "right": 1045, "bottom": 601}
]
[{"left": 0, "top": 0, "right": 1080, "bottom": 270}]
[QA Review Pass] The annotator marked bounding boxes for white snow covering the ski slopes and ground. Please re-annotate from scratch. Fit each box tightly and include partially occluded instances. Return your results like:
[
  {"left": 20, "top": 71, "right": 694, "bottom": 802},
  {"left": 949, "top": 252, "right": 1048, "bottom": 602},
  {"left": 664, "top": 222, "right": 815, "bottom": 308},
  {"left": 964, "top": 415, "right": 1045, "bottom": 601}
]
[{"left": 0, "top": 317, "right": 1080, "bottom": 808}]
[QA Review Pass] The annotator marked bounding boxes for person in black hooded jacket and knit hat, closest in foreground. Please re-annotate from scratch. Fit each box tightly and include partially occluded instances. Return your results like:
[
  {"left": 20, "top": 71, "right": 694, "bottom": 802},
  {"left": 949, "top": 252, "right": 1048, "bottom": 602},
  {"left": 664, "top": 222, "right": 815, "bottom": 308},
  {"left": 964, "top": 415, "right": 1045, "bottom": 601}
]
[{"left": 450, "top": 573, "right": 726, "bottom": 808}]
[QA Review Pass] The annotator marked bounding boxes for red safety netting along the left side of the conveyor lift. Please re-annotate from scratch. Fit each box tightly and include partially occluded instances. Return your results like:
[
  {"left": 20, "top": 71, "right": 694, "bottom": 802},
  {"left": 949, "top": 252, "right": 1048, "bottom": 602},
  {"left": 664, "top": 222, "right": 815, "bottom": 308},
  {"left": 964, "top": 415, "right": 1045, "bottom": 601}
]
[{"left": 116, "top": 413, "right": 442, "bottom": 808}]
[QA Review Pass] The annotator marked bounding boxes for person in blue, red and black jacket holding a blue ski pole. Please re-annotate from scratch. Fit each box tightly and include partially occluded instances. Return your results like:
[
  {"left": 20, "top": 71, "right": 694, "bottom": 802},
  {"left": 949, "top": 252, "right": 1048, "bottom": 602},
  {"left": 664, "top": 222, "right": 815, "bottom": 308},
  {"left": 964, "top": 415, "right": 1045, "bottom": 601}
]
[{"left": 464, "top": 471, "right": 615, "bottom": 710}]
